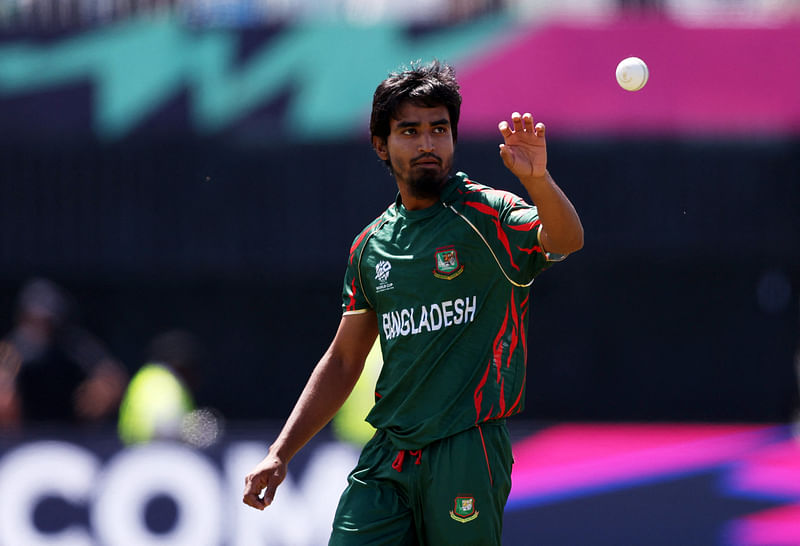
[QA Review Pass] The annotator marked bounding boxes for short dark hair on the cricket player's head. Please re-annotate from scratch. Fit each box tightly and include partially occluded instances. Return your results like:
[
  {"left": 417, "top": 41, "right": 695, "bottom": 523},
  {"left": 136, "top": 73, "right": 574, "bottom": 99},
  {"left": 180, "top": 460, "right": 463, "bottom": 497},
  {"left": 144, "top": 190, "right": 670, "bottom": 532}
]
[{"left": 369, "top": 60, "right": 461, "bottom": 146}]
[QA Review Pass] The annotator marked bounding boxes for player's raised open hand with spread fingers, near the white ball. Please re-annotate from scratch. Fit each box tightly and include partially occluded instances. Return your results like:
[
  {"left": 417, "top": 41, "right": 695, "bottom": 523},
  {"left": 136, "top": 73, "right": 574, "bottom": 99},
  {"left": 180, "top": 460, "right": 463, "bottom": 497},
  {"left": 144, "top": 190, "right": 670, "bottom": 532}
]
[{"left": 498, "top": 112, "right": 547, "bottom": 179}]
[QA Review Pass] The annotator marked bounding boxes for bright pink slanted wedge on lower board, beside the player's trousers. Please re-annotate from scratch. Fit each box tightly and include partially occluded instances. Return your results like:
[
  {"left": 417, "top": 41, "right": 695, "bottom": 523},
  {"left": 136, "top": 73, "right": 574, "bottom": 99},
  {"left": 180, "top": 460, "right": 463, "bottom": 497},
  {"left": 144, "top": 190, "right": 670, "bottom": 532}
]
[{"left": 510, "top": 423, "right": 775, "bottom": 502}]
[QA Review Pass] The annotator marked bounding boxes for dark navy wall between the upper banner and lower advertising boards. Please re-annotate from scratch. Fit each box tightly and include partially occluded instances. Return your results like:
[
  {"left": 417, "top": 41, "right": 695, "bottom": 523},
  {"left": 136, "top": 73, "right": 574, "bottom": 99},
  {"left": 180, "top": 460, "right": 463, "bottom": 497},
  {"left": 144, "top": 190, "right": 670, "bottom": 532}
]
[{"left": 0, "top": 136, "right": 800, "bottom": 421}]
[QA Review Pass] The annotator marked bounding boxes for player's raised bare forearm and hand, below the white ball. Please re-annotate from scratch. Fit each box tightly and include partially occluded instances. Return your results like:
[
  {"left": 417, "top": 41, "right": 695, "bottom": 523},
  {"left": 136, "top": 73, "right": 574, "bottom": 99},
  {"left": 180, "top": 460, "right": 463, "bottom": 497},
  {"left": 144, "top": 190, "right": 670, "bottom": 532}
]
[{"left": 498, "top": 112, "right": 583, "bottom": 255}]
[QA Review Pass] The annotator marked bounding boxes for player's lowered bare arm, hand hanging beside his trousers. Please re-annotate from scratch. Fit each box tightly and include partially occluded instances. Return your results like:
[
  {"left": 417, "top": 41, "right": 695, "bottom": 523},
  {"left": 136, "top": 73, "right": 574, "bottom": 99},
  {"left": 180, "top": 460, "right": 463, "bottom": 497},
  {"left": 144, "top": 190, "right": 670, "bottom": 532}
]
[{"left": 242, "top": 310, "right": 378, "bottom": 510}]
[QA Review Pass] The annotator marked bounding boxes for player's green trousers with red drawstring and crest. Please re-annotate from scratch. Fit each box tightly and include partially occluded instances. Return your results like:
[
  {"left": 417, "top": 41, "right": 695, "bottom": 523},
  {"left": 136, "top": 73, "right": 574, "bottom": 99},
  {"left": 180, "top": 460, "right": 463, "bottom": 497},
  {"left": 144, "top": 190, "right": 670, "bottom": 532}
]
[{"left": 328, "top": 421, "right": 514, "bottom": 546}]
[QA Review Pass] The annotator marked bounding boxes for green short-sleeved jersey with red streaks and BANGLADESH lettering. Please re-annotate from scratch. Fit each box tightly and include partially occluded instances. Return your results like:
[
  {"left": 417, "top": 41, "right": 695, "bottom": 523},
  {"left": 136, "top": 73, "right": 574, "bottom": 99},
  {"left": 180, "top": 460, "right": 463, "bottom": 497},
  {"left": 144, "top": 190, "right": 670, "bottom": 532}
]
[{"left": 343, "top": 173, "right": 560, "bottom": 449}]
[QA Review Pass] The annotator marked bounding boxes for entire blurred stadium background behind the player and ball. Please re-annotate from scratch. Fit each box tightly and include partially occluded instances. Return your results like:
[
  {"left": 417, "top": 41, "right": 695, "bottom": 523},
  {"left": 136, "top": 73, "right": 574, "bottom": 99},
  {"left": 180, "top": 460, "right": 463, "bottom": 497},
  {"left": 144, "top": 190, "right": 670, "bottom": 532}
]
[{"left": 0, "top": 0, "right": 800, "bottom": 546}]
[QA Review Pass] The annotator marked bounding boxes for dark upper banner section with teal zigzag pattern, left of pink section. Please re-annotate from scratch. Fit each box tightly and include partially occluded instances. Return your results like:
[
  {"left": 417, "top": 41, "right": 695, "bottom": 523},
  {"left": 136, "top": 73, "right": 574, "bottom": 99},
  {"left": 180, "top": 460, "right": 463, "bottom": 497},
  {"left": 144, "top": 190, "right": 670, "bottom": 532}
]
[{"left": 0, "top": 15, "right": 507, "bottom": 141}]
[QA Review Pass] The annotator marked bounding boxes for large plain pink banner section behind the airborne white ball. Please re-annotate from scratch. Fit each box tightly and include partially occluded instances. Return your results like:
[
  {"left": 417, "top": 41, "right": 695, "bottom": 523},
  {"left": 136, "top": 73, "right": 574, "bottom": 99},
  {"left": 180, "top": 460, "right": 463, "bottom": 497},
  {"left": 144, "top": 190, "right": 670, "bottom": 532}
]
[{"left": 459, "top": 19, "right": 800, "bottom": 137}]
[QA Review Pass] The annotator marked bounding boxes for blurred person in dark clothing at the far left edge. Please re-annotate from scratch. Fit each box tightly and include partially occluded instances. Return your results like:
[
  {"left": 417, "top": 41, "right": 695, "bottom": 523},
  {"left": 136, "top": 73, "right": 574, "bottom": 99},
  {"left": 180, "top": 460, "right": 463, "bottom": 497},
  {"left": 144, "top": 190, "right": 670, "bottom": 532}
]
[{"left": 0, "top": 278, "right": 128, "bottom": 427}]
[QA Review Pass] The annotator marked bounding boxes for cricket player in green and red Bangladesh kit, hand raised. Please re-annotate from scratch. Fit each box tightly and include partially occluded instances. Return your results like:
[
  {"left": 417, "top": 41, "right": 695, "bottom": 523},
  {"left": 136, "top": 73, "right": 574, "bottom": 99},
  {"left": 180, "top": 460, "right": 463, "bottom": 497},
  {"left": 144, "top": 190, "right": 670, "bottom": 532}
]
[{"left": 243, "top": 57, "right": 583, "bottom": 546}]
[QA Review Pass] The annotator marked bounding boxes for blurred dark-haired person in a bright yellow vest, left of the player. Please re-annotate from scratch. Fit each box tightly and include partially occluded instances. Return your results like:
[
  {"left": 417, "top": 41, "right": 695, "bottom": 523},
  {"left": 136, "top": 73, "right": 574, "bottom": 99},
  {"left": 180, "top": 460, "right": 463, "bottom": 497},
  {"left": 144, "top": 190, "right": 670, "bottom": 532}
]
[{"left": 118, "top": 329, "right": 220, "bottom": 447}]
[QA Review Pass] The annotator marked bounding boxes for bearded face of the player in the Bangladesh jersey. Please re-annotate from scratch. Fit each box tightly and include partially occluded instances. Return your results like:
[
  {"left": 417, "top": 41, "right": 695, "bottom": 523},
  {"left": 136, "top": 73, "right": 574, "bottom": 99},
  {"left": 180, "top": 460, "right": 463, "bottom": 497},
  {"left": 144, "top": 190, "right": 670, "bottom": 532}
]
[{"left": 376, "top": 102, "right": 455, "bottom": 198}]
